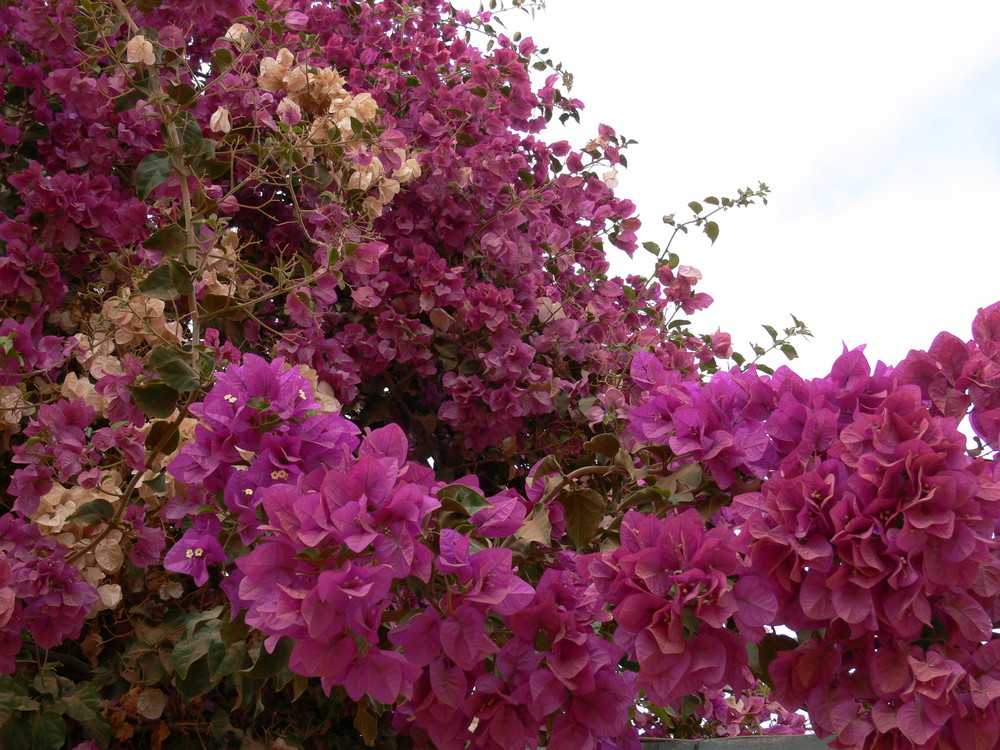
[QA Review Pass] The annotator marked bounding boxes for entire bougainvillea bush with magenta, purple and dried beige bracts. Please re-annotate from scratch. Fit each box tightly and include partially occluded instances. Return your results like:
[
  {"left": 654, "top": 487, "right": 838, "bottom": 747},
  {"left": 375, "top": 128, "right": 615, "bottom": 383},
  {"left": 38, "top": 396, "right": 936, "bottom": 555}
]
[{"left": 0, "top": 0, "right": 1000, "bottom": 750}]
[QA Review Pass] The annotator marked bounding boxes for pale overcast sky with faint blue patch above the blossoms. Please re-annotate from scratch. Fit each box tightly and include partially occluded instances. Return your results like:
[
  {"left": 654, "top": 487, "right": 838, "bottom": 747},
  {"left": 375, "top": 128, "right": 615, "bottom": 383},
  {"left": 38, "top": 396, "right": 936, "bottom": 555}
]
[{"left": 462, "top": 0, "right": 1000, "bottom": 376}]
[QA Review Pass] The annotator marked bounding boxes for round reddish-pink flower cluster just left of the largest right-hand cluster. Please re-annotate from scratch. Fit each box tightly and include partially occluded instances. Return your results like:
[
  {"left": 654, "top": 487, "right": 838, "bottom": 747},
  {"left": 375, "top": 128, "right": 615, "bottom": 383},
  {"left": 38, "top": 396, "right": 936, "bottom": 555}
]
[{"left": 578, "top": 510, "right": 778, "bottom": 706}]
